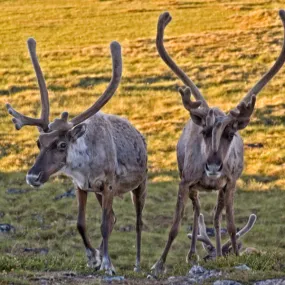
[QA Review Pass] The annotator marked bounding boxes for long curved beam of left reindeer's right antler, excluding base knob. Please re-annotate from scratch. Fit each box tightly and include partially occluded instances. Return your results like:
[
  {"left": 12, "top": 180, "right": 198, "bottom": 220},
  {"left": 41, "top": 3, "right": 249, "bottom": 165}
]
[{"left": 70, "top": 41, "right": 122, "bottom": 126}]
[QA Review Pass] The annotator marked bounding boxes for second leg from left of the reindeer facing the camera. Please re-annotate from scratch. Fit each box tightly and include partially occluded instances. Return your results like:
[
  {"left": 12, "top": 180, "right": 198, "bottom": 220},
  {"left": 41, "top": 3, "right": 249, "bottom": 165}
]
[{"left": 186, "top": 189, "right": 200, "bottom": 263}]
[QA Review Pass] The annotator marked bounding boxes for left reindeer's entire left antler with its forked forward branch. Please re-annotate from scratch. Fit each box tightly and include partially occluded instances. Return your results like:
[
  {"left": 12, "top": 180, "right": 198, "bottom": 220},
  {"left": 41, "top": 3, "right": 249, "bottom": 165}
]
[{"left": 6, "top": 38, "right": 49, "bottom": 132}]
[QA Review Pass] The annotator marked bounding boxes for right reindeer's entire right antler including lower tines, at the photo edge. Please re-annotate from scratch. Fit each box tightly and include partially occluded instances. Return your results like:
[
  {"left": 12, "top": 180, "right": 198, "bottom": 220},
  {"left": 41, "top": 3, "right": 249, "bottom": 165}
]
[{"left": 230, "top": 10, "right": 285, "bottom": 129}]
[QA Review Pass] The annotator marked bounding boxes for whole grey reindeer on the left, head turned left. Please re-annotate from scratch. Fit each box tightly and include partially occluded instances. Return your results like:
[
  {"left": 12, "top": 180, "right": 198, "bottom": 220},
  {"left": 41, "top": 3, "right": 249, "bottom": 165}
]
[{"left": 6, "top": 38, "right": 147, "bottom": 275}]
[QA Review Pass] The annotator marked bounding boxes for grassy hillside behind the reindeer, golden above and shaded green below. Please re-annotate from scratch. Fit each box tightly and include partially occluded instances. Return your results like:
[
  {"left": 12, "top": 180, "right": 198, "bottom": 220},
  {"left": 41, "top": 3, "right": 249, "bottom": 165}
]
[{"left": 0, "top": 0, "right": 285, "bottom": 280}]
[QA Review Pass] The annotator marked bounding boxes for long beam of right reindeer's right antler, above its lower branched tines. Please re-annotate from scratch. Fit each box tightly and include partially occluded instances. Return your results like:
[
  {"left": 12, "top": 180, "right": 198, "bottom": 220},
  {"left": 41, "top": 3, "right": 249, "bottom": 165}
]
[{"left": 239, "top": 10, "right": 285, "bottom": 106}]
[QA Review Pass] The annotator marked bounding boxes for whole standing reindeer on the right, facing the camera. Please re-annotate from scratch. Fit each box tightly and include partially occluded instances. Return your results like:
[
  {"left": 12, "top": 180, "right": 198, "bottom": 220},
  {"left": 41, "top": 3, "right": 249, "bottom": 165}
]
[{"left": 152, "top": 10, "right": 285, "bottom": 275}]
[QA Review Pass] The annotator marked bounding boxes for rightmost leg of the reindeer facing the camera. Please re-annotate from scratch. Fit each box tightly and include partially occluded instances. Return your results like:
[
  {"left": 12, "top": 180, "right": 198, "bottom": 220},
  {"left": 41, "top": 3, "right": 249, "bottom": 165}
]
[{"left": 225, "top": 185, "right": 239, "bottom": 255}]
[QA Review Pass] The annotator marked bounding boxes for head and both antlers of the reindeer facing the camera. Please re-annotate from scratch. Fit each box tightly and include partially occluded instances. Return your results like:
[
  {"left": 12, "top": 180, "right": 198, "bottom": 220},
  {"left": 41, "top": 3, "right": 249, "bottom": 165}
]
[{"left": 156, "top": 10, "right": 285, "bottom": 178}]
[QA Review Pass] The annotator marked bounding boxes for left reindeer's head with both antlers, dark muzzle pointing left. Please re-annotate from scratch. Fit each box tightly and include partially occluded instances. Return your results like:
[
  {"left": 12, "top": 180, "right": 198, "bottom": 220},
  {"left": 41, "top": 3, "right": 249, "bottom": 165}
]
[{"left": 6, "top": 38, "right": 122, "bottom": 187}]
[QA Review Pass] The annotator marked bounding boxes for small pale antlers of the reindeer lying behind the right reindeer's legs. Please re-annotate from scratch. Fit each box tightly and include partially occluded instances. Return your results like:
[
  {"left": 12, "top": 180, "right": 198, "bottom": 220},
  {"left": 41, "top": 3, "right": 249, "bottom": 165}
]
[{"left": 187, "top": 214, "right": 256, "bottom": 258}]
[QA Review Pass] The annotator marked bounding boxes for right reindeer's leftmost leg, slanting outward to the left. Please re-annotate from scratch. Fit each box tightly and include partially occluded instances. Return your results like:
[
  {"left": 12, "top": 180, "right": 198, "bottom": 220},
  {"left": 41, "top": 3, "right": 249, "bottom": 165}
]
[{"left": 151, "top": 181, "right": 189, "bottom": 276}]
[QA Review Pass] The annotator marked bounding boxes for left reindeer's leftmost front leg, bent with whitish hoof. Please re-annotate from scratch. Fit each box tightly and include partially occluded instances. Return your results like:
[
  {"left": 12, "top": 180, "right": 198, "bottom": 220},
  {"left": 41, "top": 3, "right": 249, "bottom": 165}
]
[{"left": 77, "top": 188, "right": 101, "bottom": 269}]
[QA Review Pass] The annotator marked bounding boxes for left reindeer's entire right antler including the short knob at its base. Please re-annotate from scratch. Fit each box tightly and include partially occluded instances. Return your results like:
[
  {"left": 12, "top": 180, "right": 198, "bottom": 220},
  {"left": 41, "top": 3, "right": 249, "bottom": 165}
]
[{"left": 49, "top": 41, "right": 122, "bottom": 131}]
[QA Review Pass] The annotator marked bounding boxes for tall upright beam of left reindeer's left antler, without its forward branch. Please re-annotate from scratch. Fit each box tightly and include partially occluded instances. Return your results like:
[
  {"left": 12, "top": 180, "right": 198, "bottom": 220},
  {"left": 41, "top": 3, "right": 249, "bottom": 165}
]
[{"left": 27, "top": 38, "right": 49, "bottom": 131}]
